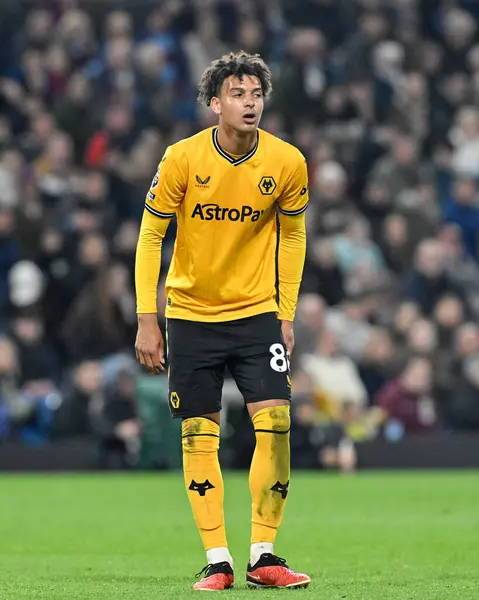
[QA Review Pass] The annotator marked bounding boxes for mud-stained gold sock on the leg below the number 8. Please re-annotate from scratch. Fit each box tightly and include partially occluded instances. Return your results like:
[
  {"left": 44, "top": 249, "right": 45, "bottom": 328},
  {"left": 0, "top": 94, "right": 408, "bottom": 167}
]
[{"left": 249, "top": 405, "right": 291, "bottom": 544}]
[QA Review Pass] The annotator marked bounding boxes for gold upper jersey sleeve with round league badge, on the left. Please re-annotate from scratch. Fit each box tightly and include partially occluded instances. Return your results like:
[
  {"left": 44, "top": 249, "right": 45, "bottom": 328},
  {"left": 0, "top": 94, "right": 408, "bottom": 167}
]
[{"left": 145, "top": 146, "right": 188, "bottom": 219}]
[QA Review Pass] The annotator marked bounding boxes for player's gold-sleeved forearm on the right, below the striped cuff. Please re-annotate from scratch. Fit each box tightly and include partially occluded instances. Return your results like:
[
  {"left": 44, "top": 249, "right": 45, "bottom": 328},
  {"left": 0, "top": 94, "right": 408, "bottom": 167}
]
[{"left": 278, "top": 213, "right": 306, "bottom": 321}]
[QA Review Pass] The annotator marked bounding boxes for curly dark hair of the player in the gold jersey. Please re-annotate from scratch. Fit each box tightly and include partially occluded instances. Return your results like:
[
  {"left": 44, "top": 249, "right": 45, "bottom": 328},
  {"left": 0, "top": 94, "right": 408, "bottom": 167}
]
[{"left": 198, "top": 50, "right": 273, "bottom": 106}]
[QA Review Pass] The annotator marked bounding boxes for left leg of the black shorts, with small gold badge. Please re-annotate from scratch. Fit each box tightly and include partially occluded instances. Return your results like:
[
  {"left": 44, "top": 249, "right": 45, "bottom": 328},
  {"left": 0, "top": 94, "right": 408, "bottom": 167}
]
[{"left": 167, "top": 319, "right": 227, "bottom": 418}]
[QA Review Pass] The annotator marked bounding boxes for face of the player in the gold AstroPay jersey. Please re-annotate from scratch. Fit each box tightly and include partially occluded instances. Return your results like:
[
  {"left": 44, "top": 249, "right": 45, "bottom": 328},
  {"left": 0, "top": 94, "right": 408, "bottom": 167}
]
[{"left": 211, "top": 75, "right": 264, "bottom": 133}]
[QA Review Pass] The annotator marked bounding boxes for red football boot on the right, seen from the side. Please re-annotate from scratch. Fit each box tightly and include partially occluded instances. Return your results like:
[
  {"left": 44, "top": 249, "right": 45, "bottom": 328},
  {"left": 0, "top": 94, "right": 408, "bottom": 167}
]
[{"left": 246, "top": 554, "right": 311, "bottom": 588}]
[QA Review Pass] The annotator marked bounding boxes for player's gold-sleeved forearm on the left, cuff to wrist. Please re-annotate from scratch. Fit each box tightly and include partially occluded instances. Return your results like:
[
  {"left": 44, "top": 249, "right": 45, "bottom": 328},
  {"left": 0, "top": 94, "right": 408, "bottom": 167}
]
[{"left": 135, "top": 211, "right": 169, "bottom": 314}]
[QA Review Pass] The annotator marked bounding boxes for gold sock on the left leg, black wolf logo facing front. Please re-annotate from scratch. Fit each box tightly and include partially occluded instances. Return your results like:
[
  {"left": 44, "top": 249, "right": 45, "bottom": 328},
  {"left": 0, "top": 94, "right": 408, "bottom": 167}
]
[{"left": 182, "top": 417, "right": 227, "bottom": 550}]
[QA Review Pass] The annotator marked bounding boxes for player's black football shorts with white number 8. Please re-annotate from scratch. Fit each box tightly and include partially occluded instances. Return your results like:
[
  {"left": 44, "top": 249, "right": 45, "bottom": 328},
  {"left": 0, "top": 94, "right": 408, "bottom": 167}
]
[{"left": 167, "top": 313, "right": 291, "bottom": 418}]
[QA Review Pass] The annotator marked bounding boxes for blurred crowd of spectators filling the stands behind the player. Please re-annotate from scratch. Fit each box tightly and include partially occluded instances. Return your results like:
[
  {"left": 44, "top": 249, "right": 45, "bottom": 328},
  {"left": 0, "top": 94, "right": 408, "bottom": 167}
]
[{"left": 0, "top": 0, "right": 479, "bottom": 464}]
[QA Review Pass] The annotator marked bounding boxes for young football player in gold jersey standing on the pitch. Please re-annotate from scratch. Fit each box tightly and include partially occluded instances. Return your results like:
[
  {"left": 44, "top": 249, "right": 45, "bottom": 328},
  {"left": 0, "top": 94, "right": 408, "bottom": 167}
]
[{"left": 136, "top": 52, "right": 310, "bottom": 590}]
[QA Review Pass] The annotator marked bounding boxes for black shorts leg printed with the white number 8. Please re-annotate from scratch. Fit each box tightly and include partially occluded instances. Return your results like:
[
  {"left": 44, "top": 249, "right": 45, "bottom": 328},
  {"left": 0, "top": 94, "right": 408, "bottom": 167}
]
[{"left": 227, "top": 313, "right": 291, "bottom": 403}]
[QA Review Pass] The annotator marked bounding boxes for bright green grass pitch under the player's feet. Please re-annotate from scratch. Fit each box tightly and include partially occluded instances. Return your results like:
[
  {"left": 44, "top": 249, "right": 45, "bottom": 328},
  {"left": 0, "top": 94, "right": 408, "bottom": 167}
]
[{"left": 0, "top": 472, "right": 479, "bottom": 600}]
